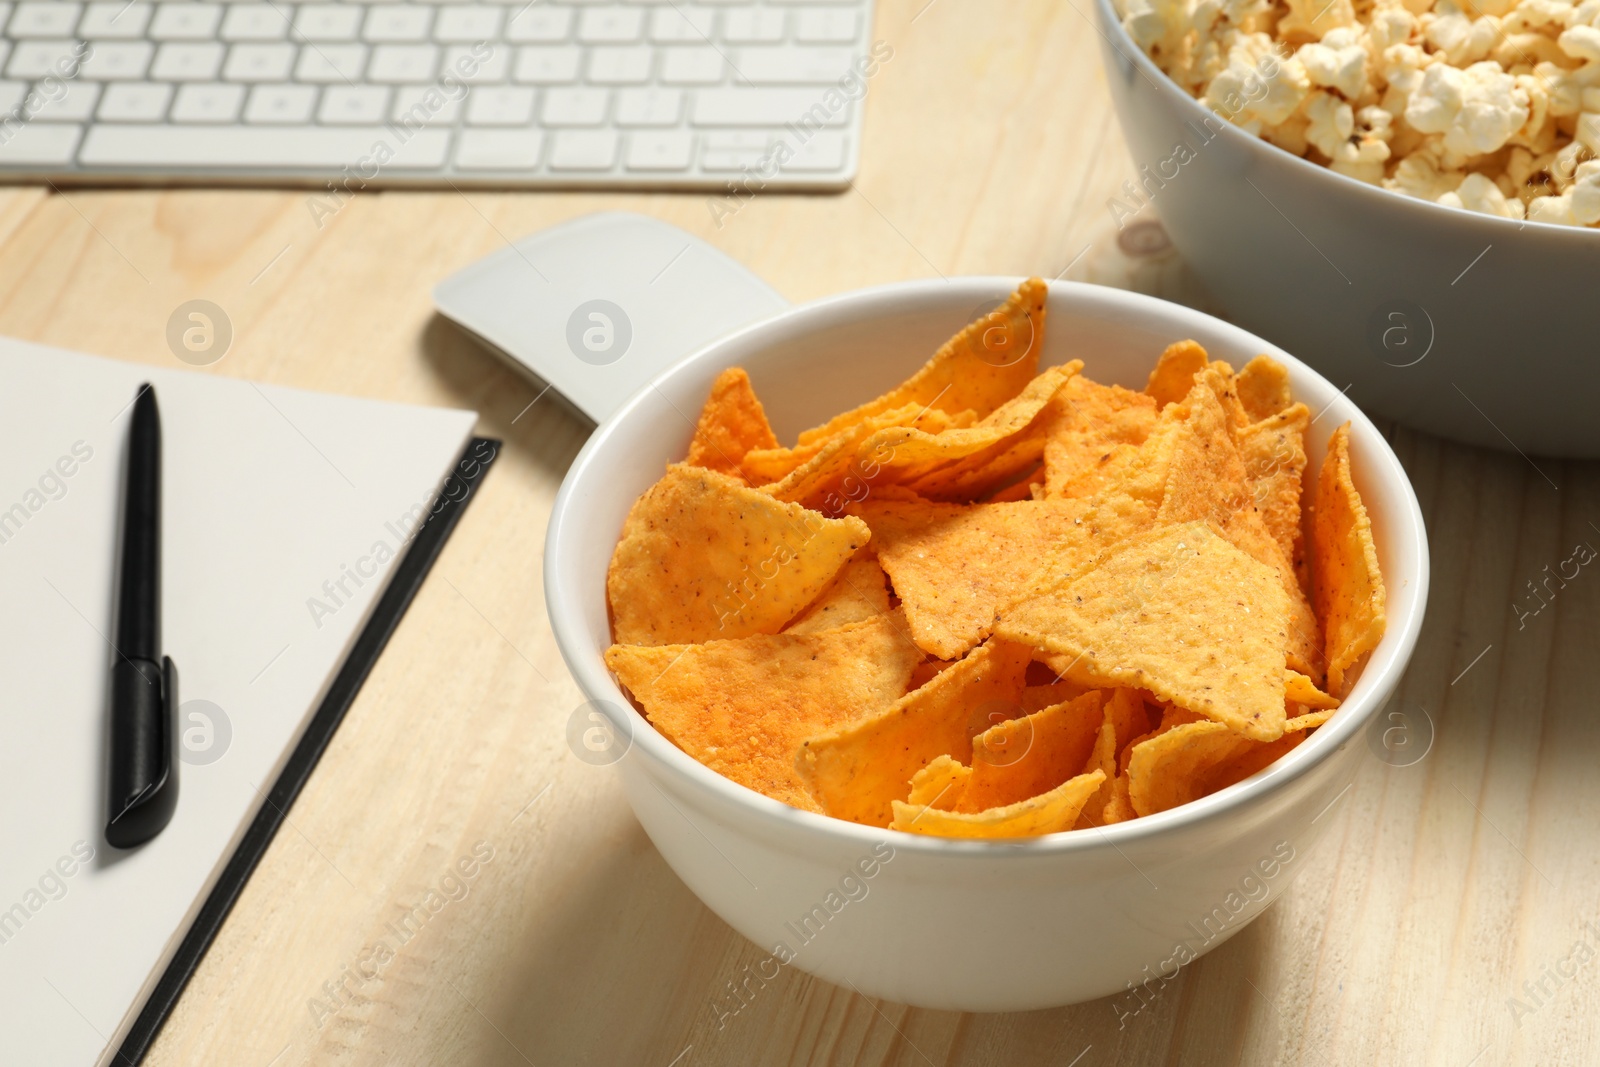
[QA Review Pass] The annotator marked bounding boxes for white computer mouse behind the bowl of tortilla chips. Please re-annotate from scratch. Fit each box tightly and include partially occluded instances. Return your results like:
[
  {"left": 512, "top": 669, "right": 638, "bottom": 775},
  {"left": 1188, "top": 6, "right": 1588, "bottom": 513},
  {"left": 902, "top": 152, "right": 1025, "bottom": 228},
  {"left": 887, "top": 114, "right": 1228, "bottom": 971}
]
[{"left": 434, "top": 211, "right": 789, "bottom": 422}]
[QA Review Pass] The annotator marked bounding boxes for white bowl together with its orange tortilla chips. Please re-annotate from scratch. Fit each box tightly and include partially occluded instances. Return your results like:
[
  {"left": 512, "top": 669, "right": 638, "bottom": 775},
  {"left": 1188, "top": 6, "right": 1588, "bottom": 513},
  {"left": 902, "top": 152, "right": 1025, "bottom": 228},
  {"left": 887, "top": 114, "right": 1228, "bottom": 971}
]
[{"left": 544, "top": 278, "right": 1429, "bottom": 1022}]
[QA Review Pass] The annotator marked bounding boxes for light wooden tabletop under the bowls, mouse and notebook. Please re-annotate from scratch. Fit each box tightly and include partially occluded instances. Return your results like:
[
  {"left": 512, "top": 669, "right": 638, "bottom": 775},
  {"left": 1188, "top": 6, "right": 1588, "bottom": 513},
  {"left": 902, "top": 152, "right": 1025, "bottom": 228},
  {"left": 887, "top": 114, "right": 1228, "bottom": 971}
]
[{"left": 0, "top": 0, "right": 1600, "bottom": 1067}]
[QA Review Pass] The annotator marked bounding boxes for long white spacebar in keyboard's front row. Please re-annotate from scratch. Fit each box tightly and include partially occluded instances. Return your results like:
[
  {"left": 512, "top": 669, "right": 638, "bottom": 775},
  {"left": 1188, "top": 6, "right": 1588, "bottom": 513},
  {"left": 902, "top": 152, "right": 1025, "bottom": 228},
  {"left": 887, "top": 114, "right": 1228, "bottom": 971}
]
[{"left": 78, "top": 125, "right": 450, "bottom": 170}]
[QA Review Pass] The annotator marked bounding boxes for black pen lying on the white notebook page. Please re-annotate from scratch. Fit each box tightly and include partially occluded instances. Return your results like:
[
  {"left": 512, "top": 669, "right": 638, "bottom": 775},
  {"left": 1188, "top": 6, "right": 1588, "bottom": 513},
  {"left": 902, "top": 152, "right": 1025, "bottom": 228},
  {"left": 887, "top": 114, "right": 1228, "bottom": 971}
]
[{"left": 106, "top": 384, "right": 178, "bottom": 848}]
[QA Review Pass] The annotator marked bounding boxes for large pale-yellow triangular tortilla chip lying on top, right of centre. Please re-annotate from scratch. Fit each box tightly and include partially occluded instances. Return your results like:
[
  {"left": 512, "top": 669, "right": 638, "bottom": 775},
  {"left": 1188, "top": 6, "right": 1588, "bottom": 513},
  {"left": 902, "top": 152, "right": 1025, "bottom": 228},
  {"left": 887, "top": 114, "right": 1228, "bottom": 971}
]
[{"left": 994, "top": 523, "right": 1290, "bottom": 741}]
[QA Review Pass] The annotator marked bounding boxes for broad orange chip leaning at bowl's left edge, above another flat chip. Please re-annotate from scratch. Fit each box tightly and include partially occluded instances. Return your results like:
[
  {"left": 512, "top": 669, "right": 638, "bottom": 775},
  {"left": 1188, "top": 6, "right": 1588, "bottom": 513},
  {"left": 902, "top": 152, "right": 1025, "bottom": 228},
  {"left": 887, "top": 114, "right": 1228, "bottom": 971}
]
[{"left": 606, "top": 464, "right": 872, "bottom": 645}]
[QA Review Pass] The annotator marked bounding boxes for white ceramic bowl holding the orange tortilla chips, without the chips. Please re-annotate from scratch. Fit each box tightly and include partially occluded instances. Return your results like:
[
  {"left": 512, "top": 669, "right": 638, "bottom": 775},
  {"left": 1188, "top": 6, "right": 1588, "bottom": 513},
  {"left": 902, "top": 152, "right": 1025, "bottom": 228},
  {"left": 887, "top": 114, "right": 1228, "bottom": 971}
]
[{"left": 544, "top": 278, "right": 1427, "bottom": 1011}]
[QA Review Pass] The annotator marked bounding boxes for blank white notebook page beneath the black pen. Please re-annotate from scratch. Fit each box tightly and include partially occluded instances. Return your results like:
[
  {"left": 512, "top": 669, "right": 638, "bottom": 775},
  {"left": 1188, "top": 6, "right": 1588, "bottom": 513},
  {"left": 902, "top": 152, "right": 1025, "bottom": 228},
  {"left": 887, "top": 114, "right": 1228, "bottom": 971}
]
[{"left": 0, "top": 338, "right": 477, "bottom": 1067}]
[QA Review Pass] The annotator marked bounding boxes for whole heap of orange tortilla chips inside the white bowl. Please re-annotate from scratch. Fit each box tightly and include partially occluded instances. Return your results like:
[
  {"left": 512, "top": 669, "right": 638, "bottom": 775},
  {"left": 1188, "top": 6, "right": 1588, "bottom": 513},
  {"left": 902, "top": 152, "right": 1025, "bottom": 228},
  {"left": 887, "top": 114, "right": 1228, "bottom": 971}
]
[{"left": 606, "top": 278, "right": 1384, "bottom": 838}]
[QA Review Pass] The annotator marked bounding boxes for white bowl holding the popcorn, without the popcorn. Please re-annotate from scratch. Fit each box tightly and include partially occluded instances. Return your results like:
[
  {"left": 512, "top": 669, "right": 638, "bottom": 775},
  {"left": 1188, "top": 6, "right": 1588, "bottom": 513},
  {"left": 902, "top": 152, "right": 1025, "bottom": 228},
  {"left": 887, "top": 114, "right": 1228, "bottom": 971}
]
[{"left": 1094, "top": 0, "right": 1600, "bottom": 458}]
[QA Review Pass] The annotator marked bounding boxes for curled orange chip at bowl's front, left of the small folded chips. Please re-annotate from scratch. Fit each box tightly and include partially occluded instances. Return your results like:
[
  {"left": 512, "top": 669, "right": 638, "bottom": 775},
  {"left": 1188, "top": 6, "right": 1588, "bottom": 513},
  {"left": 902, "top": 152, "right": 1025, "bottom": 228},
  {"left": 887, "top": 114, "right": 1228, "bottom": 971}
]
[{"left": 795, "top": 641, "right": 1029, "bottom": 827}]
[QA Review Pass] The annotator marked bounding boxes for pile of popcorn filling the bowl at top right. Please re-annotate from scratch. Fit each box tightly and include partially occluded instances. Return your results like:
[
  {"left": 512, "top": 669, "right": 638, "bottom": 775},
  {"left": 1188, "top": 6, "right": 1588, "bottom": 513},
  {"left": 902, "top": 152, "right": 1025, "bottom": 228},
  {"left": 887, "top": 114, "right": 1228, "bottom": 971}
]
[{"left": 1117, "top": 0, "right": 1600, "bottom": 226}]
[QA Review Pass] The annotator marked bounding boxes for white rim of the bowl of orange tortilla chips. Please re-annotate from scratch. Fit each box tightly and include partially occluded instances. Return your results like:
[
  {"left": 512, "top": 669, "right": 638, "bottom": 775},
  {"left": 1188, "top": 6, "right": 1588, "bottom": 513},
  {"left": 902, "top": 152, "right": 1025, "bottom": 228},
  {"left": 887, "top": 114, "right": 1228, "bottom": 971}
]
[{"left": 542, "top": 275, "right": 1429, "bottom": 859}]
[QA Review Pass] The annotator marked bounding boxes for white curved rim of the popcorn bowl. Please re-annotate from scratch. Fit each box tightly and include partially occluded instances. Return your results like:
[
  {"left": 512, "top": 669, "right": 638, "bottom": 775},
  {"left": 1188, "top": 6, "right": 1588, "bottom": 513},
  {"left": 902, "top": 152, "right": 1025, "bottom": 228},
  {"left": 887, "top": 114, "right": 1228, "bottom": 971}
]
[{"left": 1080, "top": 0, "right": 1600, "bottom": 242}]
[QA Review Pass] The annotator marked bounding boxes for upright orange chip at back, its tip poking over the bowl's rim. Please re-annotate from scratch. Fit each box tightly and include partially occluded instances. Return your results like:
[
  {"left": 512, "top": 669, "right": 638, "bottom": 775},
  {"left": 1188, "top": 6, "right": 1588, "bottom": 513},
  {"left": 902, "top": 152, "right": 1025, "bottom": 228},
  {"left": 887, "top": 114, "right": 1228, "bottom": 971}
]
[{"left": 798, "top": 278, "right": 1050, "bottom": 445}]
